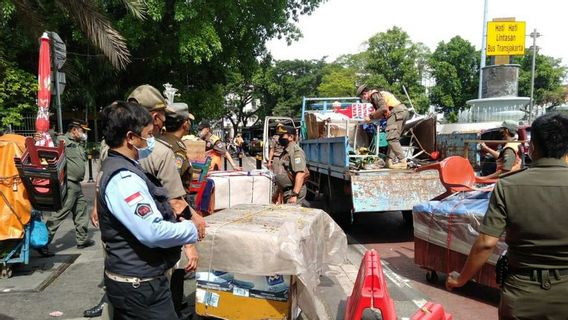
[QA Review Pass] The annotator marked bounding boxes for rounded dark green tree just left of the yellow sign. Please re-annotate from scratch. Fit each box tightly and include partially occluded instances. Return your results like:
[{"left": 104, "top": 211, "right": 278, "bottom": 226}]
[{"left": 429, "top": 36, "right": 479, "bottom": 114}]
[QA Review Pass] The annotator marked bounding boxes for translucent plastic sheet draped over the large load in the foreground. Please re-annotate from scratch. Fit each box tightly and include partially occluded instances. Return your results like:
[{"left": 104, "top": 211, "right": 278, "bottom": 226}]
[{"left": 198, "top": 205, "right": 347, "bottom": 319}]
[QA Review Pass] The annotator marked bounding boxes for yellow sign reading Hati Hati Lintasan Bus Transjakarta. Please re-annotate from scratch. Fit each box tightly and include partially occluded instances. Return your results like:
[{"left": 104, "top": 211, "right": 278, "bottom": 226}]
[{"left": 486, "top": 21, "right": 526, "bottom": 56}]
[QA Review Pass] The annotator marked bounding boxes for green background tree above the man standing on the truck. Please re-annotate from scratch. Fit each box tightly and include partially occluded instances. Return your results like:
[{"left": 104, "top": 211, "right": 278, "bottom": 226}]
[{"left": 361, "top": 27, "right": 428, "bottom": 111}]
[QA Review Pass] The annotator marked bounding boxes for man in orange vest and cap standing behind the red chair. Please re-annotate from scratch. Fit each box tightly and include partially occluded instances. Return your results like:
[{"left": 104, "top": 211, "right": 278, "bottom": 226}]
[{"left": 481, "top": 120, "right": 522, "bottom": 179}]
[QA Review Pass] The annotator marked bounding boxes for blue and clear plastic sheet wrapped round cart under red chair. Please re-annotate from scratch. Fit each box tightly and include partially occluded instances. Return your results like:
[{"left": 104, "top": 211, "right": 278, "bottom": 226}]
[{"left": 412, "top": 191, "right": 507, "bottom": 265}]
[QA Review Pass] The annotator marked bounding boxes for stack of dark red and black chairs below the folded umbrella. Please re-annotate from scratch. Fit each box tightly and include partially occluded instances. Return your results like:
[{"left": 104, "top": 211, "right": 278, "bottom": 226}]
[{"left": 14, "top": 138, "right": 67, "bottom": 211}]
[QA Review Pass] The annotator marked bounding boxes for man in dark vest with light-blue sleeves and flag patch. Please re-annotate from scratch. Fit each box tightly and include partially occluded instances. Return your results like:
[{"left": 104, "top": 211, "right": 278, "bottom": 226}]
[{"left": 97, "top": 102, "right": 197, "bottom": 319}]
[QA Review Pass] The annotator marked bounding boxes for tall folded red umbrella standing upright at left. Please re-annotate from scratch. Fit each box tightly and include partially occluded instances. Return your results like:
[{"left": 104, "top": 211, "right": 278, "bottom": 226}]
[{"left": 36, "top": 32, "right": 53, "bottom": 147}]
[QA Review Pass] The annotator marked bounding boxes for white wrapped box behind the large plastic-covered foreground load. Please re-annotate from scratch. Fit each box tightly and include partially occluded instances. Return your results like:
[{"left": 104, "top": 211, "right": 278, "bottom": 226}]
[{"left": 208, "top": 170, "right": 272, "bottom": 210}]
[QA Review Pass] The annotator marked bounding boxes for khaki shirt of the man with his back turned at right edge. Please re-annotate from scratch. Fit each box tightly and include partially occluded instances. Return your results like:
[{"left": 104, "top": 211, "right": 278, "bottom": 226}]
[{"left": 479, "top": 158, "right": 568, "bottom": 269}]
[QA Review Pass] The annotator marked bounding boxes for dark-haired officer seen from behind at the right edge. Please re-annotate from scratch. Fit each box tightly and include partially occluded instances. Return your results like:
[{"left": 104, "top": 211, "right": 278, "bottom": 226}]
[{"left": 446, "top": 113, "right": 568, "bottom": 319}]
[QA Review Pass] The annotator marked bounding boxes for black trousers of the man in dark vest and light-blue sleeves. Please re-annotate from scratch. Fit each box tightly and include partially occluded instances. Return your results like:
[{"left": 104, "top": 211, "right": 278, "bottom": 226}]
[{"left": 105, "top": 276, "right": 179, "bottom": 320}]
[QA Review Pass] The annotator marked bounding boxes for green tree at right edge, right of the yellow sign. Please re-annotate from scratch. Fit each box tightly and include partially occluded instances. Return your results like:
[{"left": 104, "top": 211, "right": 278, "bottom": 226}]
[{"left": 514, "top": 50, "right": 568, "bottom": 106}]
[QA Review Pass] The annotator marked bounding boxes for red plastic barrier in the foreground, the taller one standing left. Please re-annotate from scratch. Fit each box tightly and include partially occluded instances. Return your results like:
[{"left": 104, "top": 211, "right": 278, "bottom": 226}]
[{"left": 344, "top": 250, "right": 396, "bottom": 320}]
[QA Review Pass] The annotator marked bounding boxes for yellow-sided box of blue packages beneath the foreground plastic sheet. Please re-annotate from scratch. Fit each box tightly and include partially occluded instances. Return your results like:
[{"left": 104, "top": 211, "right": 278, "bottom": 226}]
[{"left": 195, "top": 271, "right": 298, "bottom": 320}]
